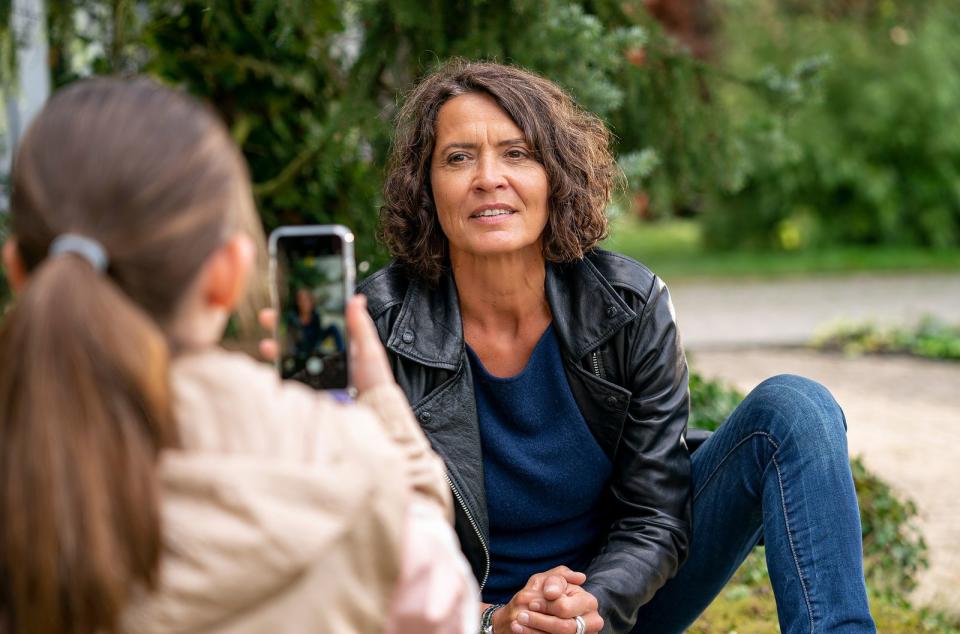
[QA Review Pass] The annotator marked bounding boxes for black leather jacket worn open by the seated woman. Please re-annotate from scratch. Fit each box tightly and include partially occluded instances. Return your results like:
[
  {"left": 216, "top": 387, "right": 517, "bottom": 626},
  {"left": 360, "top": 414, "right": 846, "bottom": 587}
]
[{"left": 358, "top": 250, "right": 691, "bottom": 632}]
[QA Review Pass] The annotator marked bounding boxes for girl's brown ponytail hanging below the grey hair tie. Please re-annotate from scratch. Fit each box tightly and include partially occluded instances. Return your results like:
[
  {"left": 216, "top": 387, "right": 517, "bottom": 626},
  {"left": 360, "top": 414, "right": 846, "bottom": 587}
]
[{"left": 0, "top": 256, "right": 178, "bottom": 634}]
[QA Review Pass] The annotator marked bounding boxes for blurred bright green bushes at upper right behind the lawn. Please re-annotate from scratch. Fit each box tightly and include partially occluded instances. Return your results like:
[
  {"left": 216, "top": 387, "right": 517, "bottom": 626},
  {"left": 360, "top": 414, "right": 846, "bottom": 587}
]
[{"left": 704, "top": 0, "right": 960, "bottom": 250}]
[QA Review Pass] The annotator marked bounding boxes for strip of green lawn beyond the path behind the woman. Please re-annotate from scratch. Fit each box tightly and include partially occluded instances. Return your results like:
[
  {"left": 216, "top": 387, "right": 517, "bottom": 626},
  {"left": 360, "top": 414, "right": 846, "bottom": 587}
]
[{"left": 602, "top": 218, "right": 960, "bottom": 282}]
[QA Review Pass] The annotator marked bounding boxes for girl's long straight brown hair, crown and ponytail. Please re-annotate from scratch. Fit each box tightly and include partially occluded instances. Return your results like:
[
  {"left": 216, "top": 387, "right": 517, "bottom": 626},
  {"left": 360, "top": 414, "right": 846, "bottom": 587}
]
[{"left": 0, "top": 79, "right": 256, "bottom": 634}]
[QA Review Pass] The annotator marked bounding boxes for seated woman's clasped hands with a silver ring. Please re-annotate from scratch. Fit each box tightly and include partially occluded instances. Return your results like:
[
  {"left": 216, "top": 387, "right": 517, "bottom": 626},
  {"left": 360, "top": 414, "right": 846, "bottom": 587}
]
[{"left": 493, "top": 566, "right": 603, "bottom": 634}]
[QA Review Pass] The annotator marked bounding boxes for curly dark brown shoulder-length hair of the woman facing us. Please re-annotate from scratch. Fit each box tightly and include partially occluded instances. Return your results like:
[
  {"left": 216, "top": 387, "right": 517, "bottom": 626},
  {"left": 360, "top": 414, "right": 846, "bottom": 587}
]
[{"left": 379, "top": 59, "right": 618, "bottom": 281}]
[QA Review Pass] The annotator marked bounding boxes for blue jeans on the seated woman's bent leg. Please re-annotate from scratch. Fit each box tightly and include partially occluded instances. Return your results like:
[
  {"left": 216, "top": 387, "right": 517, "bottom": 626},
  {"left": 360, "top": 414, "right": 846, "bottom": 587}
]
[{"left": 633, "top": 375, "right": 876, "bottom": 634}]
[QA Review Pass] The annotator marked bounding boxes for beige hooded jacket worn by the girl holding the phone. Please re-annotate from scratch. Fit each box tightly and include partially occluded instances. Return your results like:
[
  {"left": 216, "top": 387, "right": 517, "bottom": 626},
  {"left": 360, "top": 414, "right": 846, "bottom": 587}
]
[{"left": 124, "top": 349, "right": 477, "bottom": 634}]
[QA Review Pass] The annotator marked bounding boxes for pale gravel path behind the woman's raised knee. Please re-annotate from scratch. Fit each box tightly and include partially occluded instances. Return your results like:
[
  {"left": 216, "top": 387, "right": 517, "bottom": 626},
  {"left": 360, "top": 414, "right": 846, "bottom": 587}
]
[{"left": 671, "top": 274, "right": 960, "bottom": 614}]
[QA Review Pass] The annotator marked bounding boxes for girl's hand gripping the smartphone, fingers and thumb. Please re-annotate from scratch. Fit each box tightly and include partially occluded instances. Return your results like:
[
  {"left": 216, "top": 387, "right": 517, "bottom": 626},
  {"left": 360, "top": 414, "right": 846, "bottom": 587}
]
[{"left": 258, "top": 295, "right": 394, "bottom": 394}]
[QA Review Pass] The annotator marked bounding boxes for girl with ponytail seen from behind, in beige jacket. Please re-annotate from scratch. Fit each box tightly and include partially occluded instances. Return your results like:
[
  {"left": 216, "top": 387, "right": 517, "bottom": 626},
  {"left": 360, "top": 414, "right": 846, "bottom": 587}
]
[{"left": 0, "top": 79, "right": 476, "bottom": 634}]
